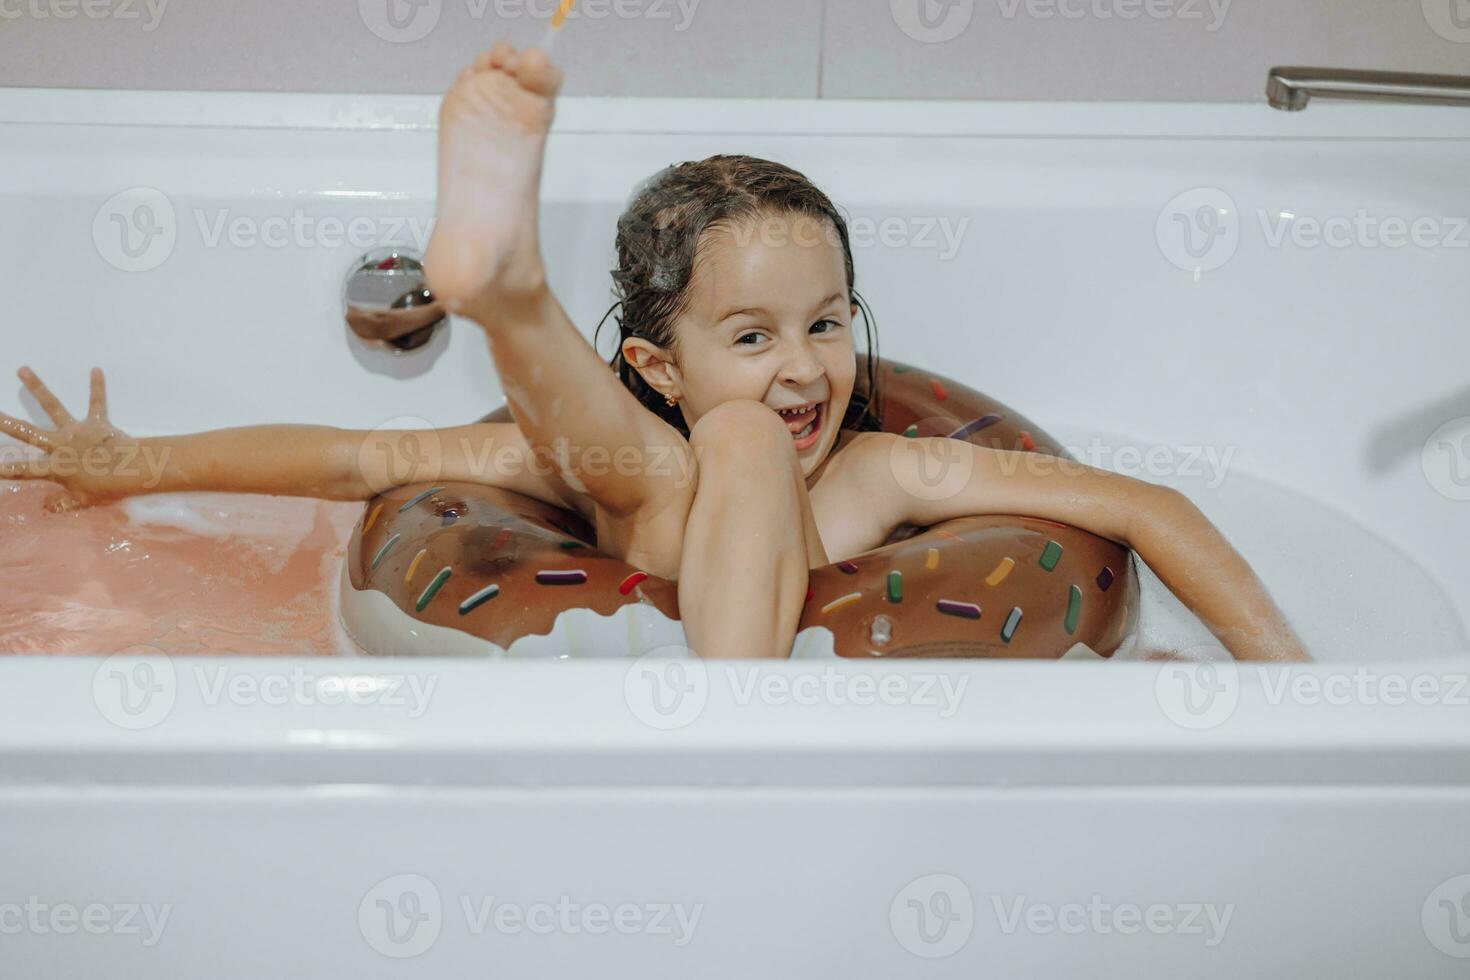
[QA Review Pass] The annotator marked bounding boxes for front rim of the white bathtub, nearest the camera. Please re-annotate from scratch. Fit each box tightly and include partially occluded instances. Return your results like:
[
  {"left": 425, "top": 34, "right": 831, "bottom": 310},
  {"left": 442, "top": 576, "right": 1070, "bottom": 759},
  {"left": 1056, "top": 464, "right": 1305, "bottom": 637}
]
[{"left": 0, "top": 657, "right": 1470, "bottom": 790}]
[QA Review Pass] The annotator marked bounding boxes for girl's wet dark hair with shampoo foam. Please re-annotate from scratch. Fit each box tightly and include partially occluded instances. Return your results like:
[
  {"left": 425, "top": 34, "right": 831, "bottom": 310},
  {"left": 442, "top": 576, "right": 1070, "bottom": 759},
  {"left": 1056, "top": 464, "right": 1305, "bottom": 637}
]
[{"left": 592, "top": 156, "right": 882, "bottom": 438}]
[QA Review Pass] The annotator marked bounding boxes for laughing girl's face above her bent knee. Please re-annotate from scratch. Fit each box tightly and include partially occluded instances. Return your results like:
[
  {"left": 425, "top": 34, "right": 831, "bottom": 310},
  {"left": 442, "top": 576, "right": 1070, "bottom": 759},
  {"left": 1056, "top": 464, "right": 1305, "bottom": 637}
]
[{"left": 626, "top": 215, "right": 857, "bottom": 476}]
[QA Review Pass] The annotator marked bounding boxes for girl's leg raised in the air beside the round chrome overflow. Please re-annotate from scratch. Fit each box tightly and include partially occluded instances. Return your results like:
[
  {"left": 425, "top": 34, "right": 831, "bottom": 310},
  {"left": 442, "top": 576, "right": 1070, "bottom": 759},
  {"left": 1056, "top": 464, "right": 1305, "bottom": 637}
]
[{"left": 425, "top": 43, "right": 692, "bottom": 514}]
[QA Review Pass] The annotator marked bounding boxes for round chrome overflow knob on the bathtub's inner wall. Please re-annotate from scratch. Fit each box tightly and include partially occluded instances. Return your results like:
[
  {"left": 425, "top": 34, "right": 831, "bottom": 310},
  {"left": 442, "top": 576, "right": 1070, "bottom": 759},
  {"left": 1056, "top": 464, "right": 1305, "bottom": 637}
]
[{"left": 343, "top": 248, "right": 445, "bottom": 351}]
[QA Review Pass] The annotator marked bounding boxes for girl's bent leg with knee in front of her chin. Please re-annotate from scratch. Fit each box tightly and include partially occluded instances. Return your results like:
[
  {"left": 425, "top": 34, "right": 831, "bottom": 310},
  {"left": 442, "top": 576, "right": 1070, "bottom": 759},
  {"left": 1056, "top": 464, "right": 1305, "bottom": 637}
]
[{"left": 679, "top": 401, "right": 828, "bottom": 658}]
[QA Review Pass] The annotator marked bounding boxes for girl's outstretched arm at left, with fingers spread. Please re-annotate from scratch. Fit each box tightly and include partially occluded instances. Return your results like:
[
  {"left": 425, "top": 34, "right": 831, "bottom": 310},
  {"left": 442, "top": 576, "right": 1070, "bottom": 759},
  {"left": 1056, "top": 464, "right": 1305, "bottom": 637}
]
[{"left": 0, "top": 369, "right": 582, "bottom": 510}]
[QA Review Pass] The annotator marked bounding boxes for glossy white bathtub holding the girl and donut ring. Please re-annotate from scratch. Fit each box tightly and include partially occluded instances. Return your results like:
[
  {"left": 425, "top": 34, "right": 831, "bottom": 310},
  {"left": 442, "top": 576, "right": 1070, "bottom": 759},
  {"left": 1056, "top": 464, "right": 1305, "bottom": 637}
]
[{"left": 0, "top": 90, "right": 1470, "bottom": 977}]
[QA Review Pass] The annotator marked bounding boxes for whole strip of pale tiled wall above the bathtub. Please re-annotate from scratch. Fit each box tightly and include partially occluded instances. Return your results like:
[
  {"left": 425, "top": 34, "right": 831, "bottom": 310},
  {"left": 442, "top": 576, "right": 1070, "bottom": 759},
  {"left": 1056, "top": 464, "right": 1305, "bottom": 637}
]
[{"left": 0, "top": 0, "right": 1470, "bottom": 101}]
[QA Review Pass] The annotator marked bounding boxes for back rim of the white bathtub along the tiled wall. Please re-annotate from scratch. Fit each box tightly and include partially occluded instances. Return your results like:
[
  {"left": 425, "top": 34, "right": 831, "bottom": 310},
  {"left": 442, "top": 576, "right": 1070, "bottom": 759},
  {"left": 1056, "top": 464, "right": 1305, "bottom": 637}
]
[{"left": 0, "top": 87, "right": 1470, "bottom": 141}]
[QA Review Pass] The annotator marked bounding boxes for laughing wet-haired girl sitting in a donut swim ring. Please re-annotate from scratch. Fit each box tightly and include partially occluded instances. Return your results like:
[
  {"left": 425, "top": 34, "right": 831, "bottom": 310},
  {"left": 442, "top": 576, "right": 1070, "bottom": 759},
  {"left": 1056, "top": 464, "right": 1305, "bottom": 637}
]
[{"left": 0, "top": 43, "right": 1307, "bottom": 660}]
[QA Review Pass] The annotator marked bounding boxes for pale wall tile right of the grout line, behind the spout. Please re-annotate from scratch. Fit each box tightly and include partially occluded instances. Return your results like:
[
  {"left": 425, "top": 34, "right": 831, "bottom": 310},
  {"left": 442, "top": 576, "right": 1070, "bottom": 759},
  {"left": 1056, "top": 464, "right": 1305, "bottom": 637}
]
[{"left": 822, "top": 0, "right": 1470, "bottom": 101}]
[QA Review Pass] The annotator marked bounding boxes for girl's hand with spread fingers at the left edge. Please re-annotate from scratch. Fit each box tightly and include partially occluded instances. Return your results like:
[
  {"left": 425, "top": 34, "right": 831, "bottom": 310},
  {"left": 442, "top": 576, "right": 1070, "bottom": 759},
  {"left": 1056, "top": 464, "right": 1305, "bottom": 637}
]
[{"left": 0, "top": 367, "right": 138, "bottom": 511}]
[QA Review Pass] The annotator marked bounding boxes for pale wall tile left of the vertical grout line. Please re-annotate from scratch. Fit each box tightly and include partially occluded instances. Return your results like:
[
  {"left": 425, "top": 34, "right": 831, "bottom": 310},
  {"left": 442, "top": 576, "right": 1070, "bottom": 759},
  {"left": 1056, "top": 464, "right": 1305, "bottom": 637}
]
[{"left": 0, "top": 0, "right": 822, "bottom": 97}]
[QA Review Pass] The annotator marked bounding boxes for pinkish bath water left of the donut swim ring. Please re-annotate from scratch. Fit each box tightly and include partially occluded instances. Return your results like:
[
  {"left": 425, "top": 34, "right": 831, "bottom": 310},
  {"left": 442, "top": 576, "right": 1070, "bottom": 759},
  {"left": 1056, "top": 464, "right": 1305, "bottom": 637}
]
[{"left": 0, "top": 482, "right": 362, "bottom": 655}]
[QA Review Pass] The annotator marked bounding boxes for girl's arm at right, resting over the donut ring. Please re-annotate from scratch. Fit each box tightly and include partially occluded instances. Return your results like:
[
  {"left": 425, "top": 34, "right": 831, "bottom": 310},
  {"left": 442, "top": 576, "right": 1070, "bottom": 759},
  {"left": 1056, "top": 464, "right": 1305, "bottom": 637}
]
[{"left": 873, "top": 436, "right": 1311, "bottom": 661}]
